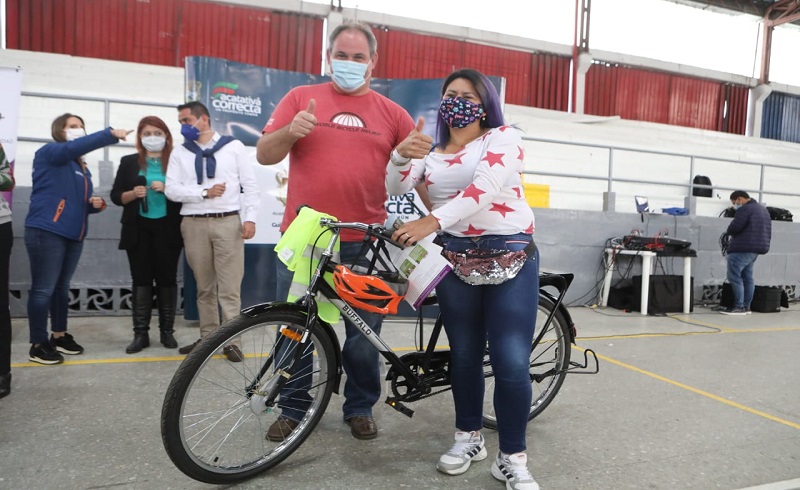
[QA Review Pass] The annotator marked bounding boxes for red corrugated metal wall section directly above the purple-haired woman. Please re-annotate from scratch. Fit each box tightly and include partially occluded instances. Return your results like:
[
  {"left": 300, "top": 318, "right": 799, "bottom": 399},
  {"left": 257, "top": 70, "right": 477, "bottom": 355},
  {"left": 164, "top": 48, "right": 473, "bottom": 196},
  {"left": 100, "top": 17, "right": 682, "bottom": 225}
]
[{"left": 373, "top": 29, "right": 571, "bottom": 111}]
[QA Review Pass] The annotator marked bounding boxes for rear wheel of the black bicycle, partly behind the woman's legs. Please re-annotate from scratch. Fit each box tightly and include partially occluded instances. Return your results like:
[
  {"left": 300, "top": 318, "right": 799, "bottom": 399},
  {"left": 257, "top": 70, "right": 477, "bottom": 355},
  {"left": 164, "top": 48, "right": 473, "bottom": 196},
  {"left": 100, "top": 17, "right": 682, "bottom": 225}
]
[{"left": 483, "top": 295, "right": 572, "bottom": 429}]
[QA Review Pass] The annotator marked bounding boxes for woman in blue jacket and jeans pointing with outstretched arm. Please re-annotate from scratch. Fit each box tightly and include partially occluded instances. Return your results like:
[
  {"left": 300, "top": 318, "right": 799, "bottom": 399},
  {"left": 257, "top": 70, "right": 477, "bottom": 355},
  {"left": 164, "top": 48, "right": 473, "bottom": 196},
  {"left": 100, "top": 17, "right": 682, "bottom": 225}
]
[{"left": 25, "top": 114, "right": 131, "bottom": 364}]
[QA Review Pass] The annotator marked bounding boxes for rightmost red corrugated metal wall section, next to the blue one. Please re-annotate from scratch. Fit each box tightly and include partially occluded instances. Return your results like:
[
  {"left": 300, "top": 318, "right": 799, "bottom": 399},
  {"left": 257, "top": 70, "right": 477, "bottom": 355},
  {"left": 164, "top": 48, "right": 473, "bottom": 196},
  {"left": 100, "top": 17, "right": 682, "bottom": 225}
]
[{"left": 584, "top": 63, "right": 748, "bottom": 134}]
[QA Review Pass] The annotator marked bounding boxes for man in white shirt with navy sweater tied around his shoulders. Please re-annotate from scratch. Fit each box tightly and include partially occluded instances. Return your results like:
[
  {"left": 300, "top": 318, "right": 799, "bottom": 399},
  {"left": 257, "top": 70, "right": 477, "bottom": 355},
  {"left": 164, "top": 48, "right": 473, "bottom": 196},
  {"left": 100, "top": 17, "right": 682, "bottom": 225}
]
[{"left": 165, "top": 101, "right": 261, "bottom": 362}]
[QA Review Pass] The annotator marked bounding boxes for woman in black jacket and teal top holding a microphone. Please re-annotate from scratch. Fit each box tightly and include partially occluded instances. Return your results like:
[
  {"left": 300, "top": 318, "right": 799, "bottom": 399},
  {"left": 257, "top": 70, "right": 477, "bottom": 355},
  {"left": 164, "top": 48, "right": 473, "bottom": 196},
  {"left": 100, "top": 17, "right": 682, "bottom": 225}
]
[{"left": 111, "top": 116, "right": 183, "bottom": 354}]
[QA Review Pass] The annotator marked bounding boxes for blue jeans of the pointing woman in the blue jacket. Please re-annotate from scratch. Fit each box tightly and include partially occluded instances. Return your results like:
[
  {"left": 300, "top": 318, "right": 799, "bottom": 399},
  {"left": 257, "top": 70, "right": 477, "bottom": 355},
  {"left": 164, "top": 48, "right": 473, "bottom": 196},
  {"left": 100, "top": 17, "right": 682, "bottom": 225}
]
[{"left": 25, "top": 227, "right": 83, "bottom": 344}]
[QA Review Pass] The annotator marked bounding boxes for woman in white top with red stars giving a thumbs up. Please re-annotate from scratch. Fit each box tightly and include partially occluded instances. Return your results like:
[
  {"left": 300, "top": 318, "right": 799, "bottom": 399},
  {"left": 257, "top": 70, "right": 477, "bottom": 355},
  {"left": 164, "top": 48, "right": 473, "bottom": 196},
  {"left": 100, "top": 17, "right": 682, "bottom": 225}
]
[{"left": 386, "top": 69, "right": 539, "bottom": 489}]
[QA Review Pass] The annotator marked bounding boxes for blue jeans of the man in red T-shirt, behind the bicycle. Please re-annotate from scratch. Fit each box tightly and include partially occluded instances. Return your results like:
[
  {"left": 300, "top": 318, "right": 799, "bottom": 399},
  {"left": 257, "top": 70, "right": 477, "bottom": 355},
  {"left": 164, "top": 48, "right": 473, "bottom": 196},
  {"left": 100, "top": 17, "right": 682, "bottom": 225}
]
[{"left": 277, "top": 242, "right": 383, "bottom": 421}]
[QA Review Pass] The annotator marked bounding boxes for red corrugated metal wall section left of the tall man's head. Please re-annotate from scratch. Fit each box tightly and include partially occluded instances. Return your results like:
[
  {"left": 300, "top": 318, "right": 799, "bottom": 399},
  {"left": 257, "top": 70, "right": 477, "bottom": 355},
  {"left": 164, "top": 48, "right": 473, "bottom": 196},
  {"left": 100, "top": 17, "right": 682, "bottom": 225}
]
[{"left": 6, "top": 0, "right": 323, "bottom": 73}]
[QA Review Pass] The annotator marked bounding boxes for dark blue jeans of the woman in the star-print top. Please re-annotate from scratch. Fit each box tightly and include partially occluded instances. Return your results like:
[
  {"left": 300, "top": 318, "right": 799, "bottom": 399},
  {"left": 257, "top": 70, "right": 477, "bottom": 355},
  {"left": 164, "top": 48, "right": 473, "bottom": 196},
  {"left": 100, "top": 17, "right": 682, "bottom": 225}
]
[{"left": 436, "top": 233, "right": 539, "bottom": 454}]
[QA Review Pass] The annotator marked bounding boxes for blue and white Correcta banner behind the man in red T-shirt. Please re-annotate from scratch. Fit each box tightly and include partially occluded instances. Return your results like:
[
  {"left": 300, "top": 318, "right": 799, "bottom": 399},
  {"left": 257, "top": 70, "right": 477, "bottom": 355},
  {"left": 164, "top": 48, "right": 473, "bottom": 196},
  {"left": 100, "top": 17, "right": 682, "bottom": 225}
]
[{"left": 185, "top": 56, "right": 505, "bottom": 244}]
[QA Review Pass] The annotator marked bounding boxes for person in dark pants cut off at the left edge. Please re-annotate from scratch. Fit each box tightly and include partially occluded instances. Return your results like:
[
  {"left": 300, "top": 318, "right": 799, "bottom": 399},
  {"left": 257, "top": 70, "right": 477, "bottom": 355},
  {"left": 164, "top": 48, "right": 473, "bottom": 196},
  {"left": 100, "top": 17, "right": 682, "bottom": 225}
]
[{"left": 0, "top": 144, "right": 14, "bottom": 398}]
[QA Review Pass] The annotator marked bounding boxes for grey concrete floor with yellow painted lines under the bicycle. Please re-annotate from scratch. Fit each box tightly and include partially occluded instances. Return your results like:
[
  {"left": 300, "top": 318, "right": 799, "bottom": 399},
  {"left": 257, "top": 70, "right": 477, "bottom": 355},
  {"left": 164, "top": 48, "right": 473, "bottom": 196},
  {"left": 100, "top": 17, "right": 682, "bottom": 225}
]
[{"left": 0, "top": 305, "right": 800, "bottom": 490}]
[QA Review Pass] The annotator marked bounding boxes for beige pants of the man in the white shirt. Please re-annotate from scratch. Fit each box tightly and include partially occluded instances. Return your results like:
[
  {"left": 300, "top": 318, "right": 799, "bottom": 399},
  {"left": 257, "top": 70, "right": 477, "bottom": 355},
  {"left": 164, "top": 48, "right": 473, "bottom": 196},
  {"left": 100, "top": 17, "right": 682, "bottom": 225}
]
[{"left": 181, "top": 215, "right": 244, "bottom": 344}]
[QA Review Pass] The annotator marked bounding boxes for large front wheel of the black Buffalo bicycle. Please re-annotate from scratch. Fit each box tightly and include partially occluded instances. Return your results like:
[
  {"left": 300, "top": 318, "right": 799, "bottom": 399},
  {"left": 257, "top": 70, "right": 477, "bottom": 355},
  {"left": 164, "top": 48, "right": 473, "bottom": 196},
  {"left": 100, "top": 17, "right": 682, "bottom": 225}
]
[{"left": 161, "top": 310, "right": 339, "bottom": 484}]
